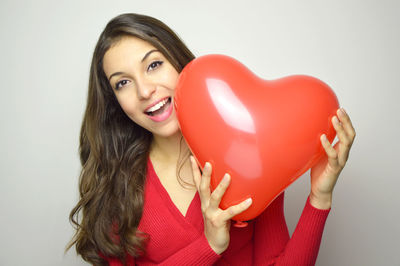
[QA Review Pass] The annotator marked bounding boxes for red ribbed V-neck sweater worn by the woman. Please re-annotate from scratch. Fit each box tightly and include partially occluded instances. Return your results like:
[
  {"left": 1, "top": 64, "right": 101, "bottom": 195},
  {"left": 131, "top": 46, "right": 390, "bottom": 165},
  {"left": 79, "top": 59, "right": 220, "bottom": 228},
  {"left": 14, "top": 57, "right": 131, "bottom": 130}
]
[{"left": 107, "top": 160, "right": 330, "bottom": 266}]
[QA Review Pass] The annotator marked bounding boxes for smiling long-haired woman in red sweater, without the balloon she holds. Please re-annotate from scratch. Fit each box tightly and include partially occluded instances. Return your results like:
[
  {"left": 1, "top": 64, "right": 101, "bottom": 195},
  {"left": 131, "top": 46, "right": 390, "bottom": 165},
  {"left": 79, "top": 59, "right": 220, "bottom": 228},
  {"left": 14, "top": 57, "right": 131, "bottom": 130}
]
[{"left": 70, "top": 14, "right": 355, "bottom": 265}]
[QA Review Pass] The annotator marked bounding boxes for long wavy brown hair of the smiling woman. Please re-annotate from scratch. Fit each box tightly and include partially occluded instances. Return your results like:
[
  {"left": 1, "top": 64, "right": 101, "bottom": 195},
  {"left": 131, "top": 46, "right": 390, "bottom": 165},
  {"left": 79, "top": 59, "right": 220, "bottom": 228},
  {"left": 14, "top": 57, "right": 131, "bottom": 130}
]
[{"left": 67, "top": 14, "right": 194, "bottom": 265}]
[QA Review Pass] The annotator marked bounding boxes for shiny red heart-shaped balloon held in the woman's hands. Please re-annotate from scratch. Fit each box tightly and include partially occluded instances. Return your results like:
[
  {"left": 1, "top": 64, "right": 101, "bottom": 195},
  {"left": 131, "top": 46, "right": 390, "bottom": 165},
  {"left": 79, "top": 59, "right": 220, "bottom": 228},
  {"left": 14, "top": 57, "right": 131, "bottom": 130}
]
[{"left": 174, "top": 55, "right": 339, "bottom": 221}]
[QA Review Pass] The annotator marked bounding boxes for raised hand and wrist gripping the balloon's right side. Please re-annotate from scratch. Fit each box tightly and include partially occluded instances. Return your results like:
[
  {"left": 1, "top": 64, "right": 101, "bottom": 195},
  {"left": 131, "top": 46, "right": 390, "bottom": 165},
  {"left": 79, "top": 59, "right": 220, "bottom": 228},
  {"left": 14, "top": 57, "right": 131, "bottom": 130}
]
[{"left": 310, "top": 108, "right": 356, "bottom": 209}]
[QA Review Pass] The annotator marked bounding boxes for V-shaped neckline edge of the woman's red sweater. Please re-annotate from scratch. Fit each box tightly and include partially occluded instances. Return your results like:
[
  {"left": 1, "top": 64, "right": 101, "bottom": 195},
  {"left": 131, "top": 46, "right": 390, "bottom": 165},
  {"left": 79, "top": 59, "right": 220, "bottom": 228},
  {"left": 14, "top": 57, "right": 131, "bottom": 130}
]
[{"left": 148, "top": 157, "right": 201, "bottom": 224}]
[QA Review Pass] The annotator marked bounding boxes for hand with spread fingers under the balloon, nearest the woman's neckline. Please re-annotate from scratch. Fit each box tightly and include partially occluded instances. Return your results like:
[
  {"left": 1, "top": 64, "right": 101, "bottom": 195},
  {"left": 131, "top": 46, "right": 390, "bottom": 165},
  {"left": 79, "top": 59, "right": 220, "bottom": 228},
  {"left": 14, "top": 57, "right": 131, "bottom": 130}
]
[{"left": 190, "top": 156, "right": 252, "bottom": 254}]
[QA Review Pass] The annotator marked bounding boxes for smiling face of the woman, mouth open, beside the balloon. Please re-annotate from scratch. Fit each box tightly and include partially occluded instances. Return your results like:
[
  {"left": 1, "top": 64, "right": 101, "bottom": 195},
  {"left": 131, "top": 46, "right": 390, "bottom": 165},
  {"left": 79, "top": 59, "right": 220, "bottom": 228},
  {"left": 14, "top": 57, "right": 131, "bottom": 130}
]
[{"left": 103, "top": 37, "right": 179, "bottom": 137}]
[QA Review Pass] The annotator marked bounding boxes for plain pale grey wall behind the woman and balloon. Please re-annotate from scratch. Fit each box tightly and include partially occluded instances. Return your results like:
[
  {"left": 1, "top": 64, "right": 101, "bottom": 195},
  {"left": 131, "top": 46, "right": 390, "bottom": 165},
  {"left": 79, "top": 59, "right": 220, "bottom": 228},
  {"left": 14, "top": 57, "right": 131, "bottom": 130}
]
[{"left": 0, "top": 0, "right": 400, "bottom": 266}]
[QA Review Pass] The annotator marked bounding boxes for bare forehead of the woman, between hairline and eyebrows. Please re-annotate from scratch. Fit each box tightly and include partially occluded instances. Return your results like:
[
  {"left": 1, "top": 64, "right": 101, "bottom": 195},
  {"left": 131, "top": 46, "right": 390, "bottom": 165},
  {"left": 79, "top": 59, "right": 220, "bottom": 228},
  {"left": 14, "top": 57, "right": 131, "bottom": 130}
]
[{"left": 103, "top": 36, "right": 156, "bottom": 73}]
